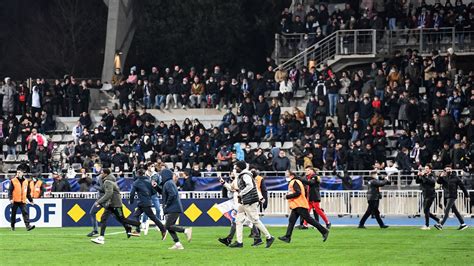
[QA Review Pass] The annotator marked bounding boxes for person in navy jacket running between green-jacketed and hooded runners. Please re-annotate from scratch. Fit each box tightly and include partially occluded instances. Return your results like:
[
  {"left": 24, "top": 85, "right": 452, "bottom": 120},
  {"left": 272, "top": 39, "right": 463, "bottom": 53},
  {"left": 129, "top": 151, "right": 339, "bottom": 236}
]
[{"left": 130, "top": 169, "right": 166, "bottom": 240}]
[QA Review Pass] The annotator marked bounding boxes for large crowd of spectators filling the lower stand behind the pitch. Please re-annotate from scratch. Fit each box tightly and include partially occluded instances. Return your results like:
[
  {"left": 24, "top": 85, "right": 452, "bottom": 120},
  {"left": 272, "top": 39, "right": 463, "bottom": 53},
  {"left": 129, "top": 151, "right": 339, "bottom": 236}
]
[{"left": 3, "top": 44, "right": 466, "bottom": 184}]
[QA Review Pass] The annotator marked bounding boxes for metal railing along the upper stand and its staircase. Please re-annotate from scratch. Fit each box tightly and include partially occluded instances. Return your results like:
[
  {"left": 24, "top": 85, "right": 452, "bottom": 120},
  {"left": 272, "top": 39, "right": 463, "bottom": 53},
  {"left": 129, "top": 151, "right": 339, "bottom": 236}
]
[{"left": 274, "top": 27, "right": 474, "bottom": 70}]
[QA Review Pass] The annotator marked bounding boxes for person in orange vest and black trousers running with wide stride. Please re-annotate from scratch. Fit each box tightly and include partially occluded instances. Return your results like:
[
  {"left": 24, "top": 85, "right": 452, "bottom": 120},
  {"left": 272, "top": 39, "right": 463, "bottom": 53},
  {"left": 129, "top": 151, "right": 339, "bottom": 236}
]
[{"left": 278, "top": 171, "right": 329, "bottom": 243}]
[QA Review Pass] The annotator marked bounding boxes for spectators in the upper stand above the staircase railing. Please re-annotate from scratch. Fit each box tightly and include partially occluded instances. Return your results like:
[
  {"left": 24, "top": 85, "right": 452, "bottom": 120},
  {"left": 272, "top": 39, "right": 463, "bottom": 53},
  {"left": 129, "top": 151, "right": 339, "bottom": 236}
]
[{"left": 280, "top": 0, "right": 474, "bottom": 50}]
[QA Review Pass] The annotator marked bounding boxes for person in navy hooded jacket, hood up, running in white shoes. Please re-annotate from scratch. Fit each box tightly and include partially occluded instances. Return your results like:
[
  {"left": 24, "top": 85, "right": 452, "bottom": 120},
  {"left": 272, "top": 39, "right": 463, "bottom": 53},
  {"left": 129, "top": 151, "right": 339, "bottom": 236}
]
[{"left": 160, "top": 169, "right": 192, "bottom": 249}]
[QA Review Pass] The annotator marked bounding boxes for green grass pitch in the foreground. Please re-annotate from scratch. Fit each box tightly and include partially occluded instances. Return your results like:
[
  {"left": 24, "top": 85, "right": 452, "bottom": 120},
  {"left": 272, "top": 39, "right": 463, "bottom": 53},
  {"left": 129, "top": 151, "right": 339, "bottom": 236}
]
[{"left": 0, "top": 227, "right": 474, "bottom": 265}]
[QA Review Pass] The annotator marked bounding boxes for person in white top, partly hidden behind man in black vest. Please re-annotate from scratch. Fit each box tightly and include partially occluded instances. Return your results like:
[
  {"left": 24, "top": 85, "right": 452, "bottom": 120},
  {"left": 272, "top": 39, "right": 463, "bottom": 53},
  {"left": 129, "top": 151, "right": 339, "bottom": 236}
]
[{"left": 218, "top": 173, "right": 263, "bottom": 246}]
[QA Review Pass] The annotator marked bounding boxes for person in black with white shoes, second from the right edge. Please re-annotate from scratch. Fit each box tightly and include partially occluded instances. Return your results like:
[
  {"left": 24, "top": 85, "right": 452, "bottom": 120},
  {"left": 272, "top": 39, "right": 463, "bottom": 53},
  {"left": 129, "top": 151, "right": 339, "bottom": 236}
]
[{"left": 416, "top": 164, "right": 439, "bottom": 230}]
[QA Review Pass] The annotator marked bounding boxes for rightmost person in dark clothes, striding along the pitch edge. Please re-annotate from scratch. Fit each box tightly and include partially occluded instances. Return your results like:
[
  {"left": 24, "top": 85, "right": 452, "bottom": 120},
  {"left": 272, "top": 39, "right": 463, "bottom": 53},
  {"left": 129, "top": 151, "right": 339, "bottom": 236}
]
[{"left": 434, "top": 166, "right": 469, "bottom": 230}]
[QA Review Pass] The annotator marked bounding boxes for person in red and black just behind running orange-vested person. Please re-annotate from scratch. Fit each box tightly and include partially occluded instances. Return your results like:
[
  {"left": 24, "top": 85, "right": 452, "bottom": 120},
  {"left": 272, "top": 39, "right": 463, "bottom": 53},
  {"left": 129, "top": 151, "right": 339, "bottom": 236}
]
[{"left": 301, "top": 166, "right": 331, "bottom": 229}]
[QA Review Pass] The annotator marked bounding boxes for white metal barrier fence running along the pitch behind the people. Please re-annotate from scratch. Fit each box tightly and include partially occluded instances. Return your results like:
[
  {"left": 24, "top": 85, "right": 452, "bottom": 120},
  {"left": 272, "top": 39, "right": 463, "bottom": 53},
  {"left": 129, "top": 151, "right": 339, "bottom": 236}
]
[{"left": 0, "top": 190, "right": 474, "bottom": 217}]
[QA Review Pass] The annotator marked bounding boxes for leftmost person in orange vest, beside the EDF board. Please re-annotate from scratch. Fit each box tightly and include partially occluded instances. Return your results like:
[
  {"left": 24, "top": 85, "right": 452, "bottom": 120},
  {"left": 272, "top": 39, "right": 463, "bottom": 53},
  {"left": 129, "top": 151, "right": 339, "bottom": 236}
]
[{"left": 8, "top": 169, "right": 35, "bottom": 231}]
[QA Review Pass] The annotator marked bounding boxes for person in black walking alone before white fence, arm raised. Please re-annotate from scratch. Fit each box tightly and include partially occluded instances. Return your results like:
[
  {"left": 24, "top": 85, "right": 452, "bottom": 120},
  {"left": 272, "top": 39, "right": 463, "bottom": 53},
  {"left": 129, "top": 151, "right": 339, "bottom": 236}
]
[{"left": 359, "top": 171, "right": 388, "bottom": 229}]
